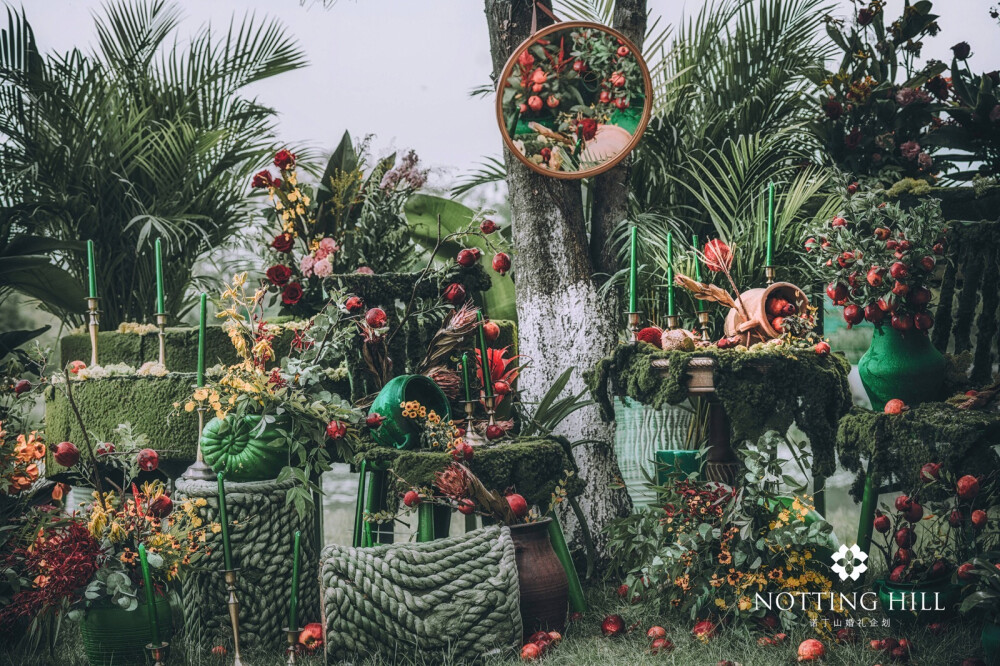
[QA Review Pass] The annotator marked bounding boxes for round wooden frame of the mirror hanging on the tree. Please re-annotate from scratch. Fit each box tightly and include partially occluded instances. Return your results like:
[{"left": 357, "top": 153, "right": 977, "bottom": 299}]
[{"left": 496, "top": 21, "right": 653, "bottom": 180}]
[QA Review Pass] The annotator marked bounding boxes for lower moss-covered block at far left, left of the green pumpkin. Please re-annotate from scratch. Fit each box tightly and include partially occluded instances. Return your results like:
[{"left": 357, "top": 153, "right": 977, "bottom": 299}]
[{"left": 45, "top": 372, "right": 198, "bottom": 476}]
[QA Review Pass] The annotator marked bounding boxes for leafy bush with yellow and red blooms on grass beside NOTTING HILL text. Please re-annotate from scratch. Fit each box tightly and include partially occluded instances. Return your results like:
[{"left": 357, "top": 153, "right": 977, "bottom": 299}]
[{"left": 609, "top": 432, "right": 833, "bottom": 631}]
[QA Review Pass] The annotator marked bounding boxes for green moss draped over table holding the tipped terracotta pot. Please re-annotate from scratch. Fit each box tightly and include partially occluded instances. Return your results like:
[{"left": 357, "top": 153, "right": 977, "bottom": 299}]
[{"left": 587, "top": 343, "right": 851, "bottom": 476}]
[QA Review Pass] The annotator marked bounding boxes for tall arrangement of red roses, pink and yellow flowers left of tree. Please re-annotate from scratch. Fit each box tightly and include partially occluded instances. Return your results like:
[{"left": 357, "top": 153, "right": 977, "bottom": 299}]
[{"left": 251, "top": 141, "right": 428, "bottom": 314}]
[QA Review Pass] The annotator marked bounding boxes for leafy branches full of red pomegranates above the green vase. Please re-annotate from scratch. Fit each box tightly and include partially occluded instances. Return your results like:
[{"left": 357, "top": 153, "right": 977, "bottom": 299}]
[{"left": 805, "top": 179, "right": 947, "bottom": 332}]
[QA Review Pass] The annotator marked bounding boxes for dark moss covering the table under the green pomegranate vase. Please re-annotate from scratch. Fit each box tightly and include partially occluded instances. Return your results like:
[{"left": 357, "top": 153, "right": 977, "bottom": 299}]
[{"left": 837, "top": 402, "right": 1000, "bottom": 501}]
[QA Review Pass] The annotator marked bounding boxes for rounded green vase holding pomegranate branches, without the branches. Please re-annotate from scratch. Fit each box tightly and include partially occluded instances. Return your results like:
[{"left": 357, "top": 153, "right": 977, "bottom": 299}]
[{"left": 858, "top": 326, "right": 945, "bottom": 412}]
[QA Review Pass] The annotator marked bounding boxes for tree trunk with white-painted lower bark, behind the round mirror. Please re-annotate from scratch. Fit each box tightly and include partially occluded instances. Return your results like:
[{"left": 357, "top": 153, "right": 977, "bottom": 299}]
[{"left": 485, "top": 0, "right": 646, "bottom": 559}]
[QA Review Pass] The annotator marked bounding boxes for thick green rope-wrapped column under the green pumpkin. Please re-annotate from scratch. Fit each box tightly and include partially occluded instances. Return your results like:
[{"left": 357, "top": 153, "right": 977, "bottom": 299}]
[{"left": 177, "top": 476, "right": 320, "bottom": 654}]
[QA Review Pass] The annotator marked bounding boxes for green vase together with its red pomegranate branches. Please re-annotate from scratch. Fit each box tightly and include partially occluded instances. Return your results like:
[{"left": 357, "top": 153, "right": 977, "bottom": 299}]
[{"left": 805, "top": 177, "right": 946, "bottom": 411}]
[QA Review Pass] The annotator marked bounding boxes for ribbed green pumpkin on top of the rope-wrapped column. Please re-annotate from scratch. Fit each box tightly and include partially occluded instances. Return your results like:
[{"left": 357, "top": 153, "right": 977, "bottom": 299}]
[{"left": 200, "top": 414, "right": 288, "bottom": 481}]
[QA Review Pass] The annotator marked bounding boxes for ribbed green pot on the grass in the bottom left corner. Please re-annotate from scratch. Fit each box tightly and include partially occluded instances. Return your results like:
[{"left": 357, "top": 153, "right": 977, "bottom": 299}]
[{"left": 80, "top": 597, "right": 174, "bottom": 666}]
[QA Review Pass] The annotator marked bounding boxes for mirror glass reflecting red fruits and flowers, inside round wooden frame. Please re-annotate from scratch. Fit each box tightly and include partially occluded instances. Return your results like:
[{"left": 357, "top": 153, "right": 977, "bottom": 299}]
[{"left": 502, "top": 28, "right": 646, "bottom": 171}]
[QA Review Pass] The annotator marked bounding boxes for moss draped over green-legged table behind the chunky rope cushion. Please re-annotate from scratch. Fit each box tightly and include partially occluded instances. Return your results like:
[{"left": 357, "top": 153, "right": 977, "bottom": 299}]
[{"left": 354, "top": 438, "right": 583, "bottom": 504}]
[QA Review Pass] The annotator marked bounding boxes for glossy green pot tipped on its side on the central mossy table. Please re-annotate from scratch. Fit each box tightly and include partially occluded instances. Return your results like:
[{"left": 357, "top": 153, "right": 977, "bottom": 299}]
[{"left": 368, "top": 375, "right": 451, "bottom": 449}]
